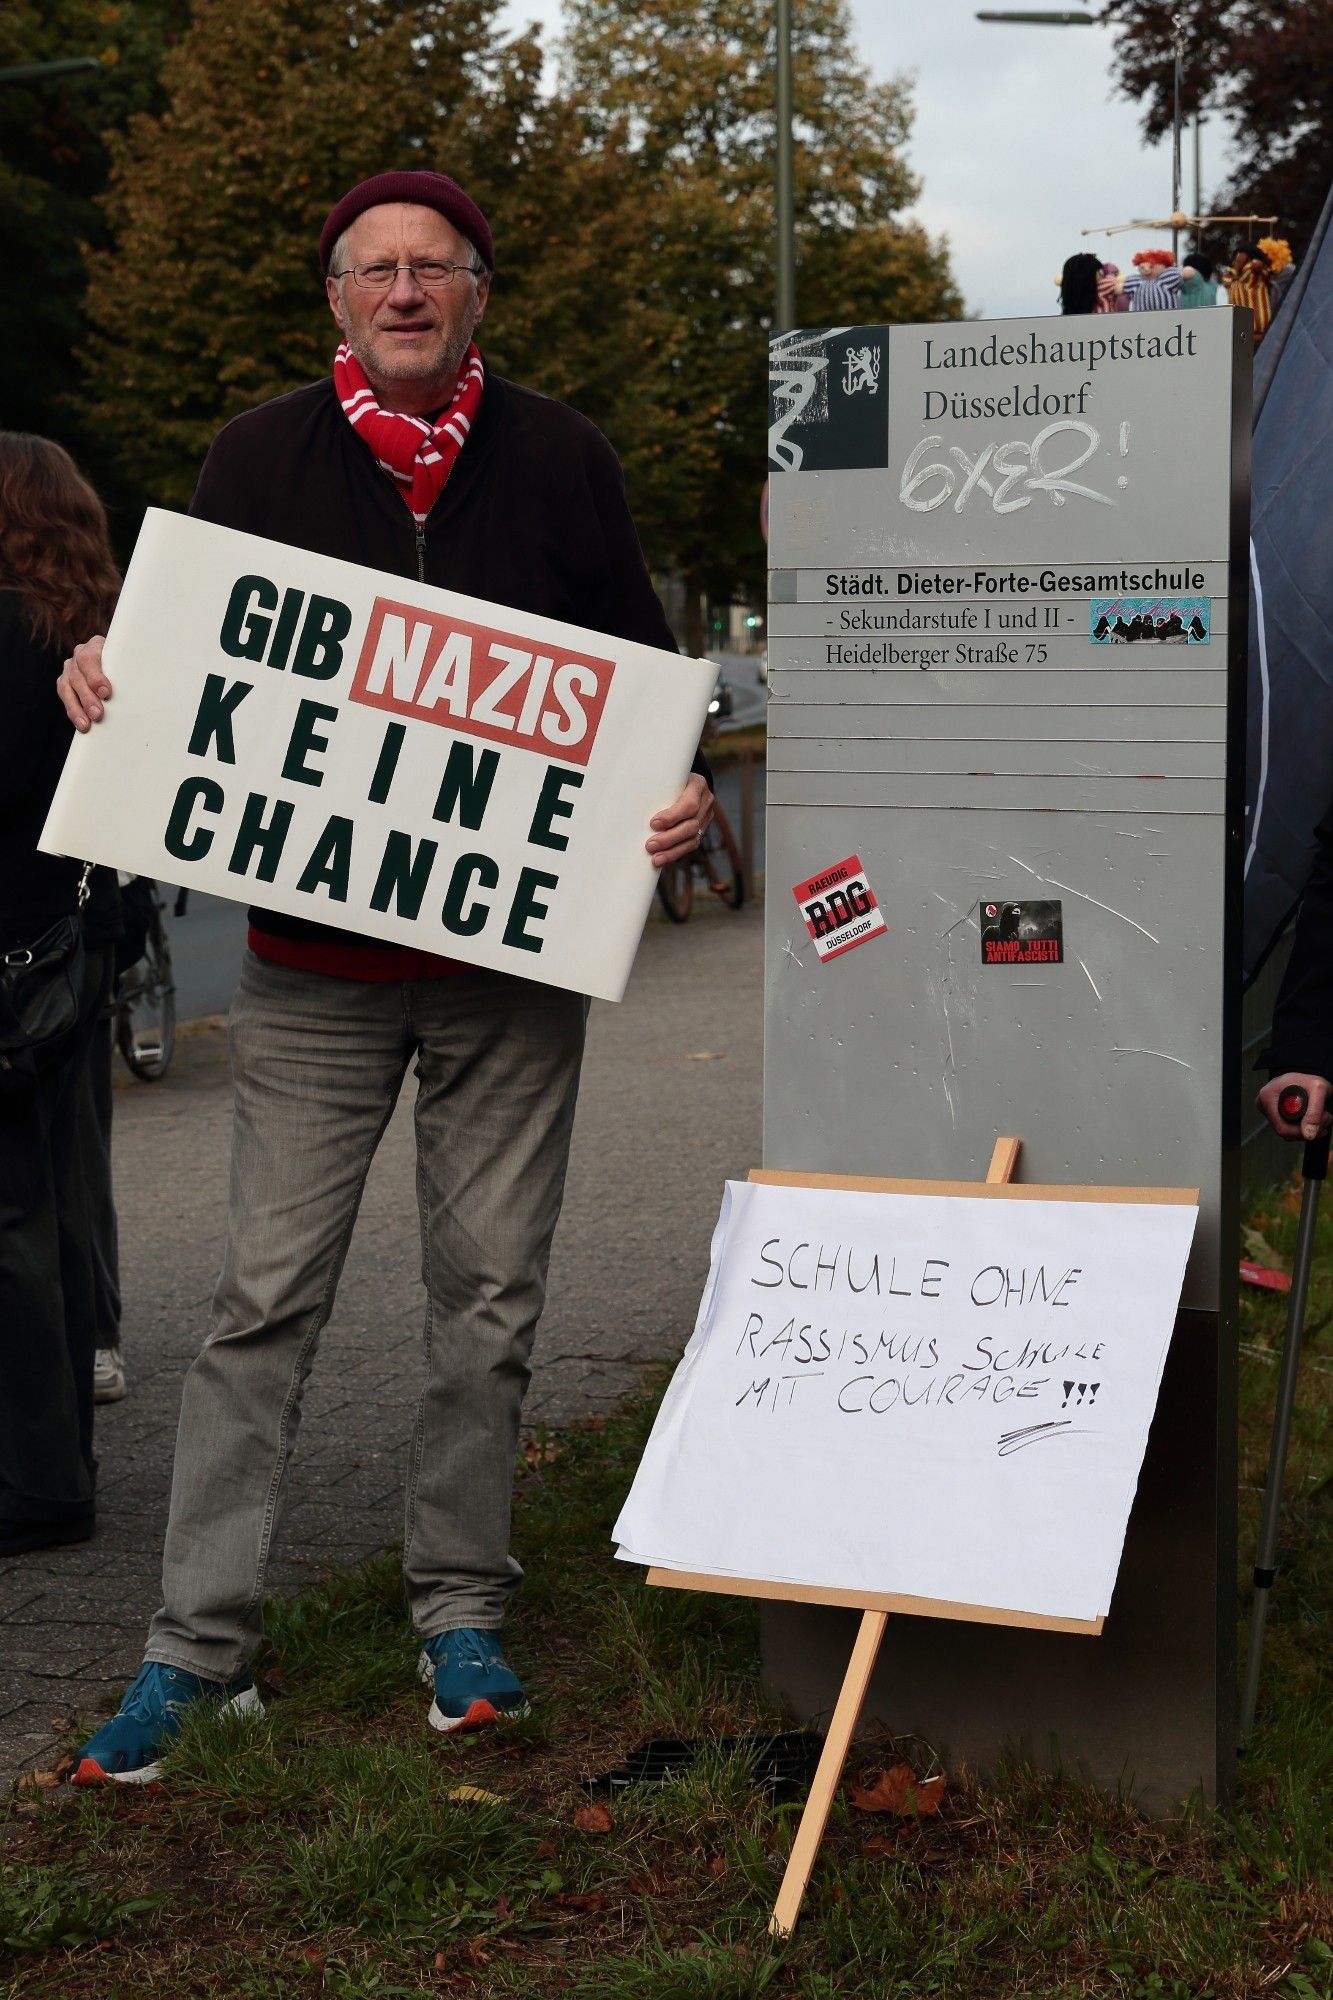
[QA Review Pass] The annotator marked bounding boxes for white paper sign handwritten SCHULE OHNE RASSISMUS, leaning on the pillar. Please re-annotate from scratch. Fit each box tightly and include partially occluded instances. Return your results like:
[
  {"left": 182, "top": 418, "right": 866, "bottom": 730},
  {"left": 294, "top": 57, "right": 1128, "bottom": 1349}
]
[{"left": 614, "top": 1182, "right": 1197, "bottom": 1620}]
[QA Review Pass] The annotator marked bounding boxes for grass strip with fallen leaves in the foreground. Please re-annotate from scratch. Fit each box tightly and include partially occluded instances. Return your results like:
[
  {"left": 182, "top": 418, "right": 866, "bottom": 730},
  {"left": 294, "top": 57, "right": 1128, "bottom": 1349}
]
[{"left": 0, "top": 1188, "right": 1333, "bottom": 2000}]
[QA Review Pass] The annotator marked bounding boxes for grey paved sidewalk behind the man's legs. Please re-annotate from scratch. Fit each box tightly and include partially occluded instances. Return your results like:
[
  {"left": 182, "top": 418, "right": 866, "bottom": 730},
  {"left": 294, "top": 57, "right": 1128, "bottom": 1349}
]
[{"left": 0, "top": 908, "right": 763, "bottom": 1774}]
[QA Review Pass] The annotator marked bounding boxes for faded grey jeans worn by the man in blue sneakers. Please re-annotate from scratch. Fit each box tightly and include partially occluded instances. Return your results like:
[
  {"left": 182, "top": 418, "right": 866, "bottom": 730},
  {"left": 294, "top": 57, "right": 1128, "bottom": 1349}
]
[{"left": 146, "top": 954, "right": 586, "bottom": 1680}]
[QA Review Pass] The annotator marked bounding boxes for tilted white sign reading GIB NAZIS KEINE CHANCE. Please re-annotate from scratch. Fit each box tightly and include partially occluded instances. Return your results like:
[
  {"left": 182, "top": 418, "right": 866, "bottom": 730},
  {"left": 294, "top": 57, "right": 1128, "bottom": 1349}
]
[{"left": 42, "top": 508, "right": 717, "bottom": 1000}]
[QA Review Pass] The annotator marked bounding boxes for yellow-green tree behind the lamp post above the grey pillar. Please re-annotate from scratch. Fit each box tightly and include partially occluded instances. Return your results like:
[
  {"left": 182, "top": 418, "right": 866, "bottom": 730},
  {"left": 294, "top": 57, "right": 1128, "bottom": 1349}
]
[{"left": 548, "top": 0, "right": 963, "bottom": 632}]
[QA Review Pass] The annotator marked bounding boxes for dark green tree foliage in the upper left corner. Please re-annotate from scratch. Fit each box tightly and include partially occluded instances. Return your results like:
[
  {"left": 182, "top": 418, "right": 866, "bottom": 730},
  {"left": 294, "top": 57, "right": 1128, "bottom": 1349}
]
[{"left": 0, "top": 0, "right": 188, "bottom": 516}]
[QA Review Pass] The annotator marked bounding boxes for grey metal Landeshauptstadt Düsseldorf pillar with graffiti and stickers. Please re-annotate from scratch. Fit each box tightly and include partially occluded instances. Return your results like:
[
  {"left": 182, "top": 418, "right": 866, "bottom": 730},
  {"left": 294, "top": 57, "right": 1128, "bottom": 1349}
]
[{"left": 765, "top": 310, "right": 1251, "bottom": 1802}]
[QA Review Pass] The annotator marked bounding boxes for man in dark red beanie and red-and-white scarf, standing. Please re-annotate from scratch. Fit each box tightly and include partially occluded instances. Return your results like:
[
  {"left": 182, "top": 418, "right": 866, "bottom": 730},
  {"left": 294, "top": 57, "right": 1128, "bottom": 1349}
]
[{"left": 60, "top": 172, "right": 713, "bottom": 1784}]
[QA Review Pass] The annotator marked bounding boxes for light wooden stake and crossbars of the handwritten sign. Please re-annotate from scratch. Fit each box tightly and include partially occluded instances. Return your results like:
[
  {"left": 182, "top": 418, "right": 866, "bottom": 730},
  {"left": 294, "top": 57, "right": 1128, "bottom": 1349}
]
[{"left": 646, "top": 1138, "right": 1199, "bottom": 1938}]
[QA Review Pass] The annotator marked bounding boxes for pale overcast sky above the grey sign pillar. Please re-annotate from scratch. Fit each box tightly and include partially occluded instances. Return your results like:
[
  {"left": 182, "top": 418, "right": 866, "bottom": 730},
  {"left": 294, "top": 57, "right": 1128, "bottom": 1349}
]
[{"left": 498, "top": 0, "right": 1223, "bottom": 318}]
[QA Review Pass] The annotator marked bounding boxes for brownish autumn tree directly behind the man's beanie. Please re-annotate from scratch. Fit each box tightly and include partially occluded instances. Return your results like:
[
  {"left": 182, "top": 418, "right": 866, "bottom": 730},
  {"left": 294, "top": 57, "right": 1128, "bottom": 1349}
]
[{"left": 79, "top": 0, "right": 548, "bottom": 506}]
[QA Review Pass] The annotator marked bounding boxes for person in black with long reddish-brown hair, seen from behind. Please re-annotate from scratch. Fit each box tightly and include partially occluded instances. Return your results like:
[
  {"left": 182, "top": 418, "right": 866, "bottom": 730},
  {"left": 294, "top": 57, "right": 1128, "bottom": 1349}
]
[{"left": 0, "top": 432, "right": 120, "bottom": 1558}]
